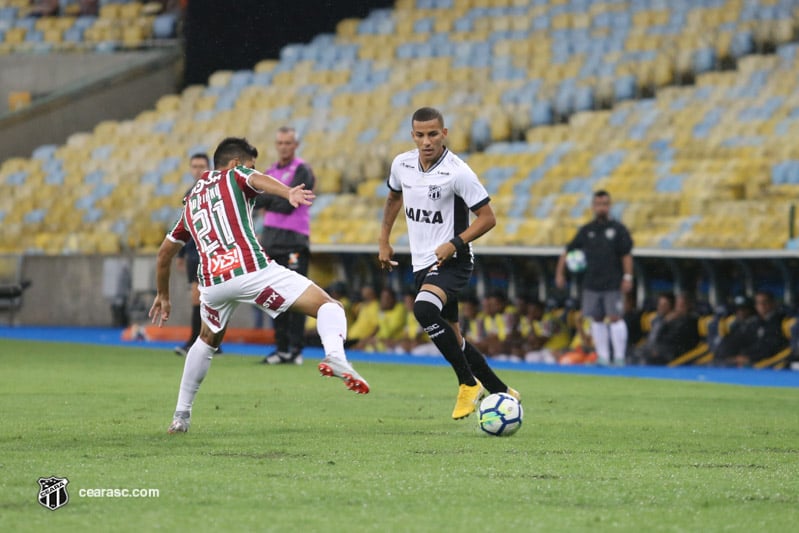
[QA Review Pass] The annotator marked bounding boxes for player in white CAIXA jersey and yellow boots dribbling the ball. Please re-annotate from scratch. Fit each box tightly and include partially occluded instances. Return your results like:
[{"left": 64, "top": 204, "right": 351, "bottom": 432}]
[{"left": 378, "top": 107, "right": 520, "bottom": 420}]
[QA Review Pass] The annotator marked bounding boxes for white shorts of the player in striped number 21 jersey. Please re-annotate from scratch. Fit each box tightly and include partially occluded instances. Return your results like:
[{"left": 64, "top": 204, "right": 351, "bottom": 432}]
[{"left": 200, "top": 261, "right": 313, "bottom": 333}]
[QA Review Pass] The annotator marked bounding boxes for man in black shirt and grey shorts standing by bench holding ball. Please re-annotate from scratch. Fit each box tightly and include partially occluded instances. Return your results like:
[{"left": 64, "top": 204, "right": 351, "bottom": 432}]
[{"left": 555, "top": 190, "right": 633, "bottom": 364}]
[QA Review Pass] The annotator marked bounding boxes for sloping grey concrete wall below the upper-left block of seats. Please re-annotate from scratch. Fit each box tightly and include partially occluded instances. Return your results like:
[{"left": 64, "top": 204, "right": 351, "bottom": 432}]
[{"left": 0, "top": 49, "right": 182, "bottom": 161}]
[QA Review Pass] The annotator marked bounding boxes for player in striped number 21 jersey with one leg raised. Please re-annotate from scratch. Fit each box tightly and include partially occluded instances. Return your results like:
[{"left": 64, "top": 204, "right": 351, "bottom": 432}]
[{"left": 150, "top": 137, "right": 369, "bottom": 433}]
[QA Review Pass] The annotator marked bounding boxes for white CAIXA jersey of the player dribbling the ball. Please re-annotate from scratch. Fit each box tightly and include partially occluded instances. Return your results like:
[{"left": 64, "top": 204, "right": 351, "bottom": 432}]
[{"left": 388, "top": 148, "right": 491, "bottom": 272}]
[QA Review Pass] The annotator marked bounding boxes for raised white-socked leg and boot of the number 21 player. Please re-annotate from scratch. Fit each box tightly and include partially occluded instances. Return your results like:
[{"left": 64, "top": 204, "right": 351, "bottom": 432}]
[{"left": 291, "top": 284, "right": 369, "bottom": 394}]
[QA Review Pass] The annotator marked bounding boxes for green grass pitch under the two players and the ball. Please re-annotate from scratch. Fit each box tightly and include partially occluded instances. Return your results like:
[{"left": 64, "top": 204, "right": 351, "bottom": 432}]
[{"left": 0, "top": 340, "right": 799, "bottom": 531}]
